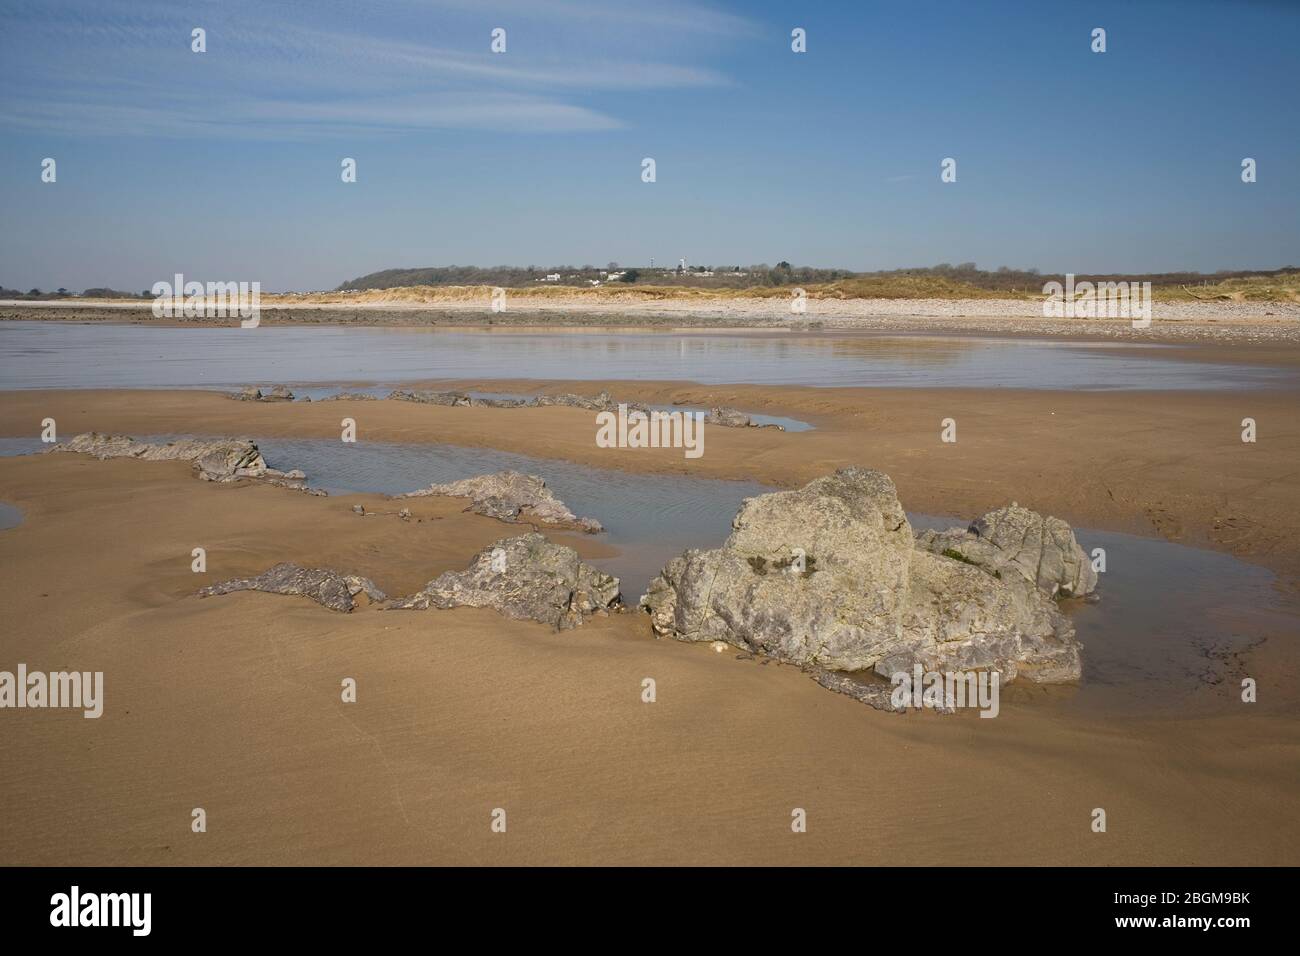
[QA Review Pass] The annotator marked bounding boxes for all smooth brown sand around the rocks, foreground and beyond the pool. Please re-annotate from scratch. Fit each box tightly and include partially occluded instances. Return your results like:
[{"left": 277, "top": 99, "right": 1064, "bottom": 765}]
[{"left": 0, "top": 382, "right": 1300, "bottom": 865}]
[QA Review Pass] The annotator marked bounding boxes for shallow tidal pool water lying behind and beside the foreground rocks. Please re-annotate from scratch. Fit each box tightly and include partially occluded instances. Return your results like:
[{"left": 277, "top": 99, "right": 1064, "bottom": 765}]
[{"left": 0, "top": 436, "right": 1296, "bottom": 714}]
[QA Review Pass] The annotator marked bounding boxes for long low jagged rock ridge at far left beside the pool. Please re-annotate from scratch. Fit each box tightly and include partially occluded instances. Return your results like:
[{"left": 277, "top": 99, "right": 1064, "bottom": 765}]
[{"left": 51, "top": 432, "right": 325, "bottom": 494}]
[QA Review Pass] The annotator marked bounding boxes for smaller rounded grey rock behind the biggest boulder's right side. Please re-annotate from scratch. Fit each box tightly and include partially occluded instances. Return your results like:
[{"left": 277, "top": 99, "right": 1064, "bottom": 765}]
[{"left": 917, "top": 502, "right": 1097, "bottom": 597}]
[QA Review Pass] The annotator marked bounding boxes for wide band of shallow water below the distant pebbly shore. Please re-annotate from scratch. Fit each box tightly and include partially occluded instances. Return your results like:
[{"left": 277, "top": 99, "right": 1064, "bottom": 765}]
[{"left": 0, "top": 321, "right": 1295, "bottom": 389}]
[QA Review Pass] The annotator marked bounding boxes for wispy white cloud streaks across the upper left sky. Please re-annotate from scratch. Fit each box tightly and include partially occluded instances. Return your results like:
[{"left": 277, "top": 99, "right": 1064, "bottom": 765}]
[{"left": 0, "top": 0, "right": 750, "bottom": 138}]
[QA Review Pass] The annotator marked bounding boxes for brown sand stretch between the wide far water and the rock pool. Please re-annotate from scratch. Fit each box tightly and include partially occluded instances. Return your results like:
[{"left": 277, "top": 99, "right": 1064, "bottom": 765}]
[{"left": 0, "top": 381, "right": 1300, "bottom": 588}]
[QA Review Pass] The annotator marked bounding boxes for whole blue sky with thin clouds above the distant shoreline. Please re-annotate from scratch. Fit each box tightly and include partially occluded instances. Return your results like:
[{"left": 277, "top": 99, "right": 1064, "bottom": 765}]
[{"left": 0, "top": 0, "right": 1300, "bottom": 291}]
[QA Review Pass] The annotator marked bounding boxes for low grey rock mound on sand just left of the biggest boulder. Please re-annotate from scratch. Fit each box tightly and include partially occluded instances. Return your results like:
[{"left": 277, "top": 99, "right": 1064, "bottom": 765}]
[{"left": 387, "top": 532, "right": 620, "bottom": 630}]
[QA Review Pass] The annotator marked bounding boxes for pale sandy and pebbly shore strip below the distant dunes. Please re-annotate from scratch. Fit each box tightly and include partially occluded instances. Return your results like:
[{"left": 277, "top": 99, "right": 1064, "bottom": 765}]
[{"left": 0, "top": 299, "right": 1300, "bottom": 351}]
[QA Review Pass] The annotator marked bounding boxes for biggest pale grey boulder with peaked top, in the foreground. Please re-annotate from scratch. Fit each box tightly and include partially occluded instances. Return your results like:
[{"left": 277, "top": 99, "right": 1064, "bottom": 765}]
[{"left": 641, "top": 468, "right": 1079, "bottom": 683}]
